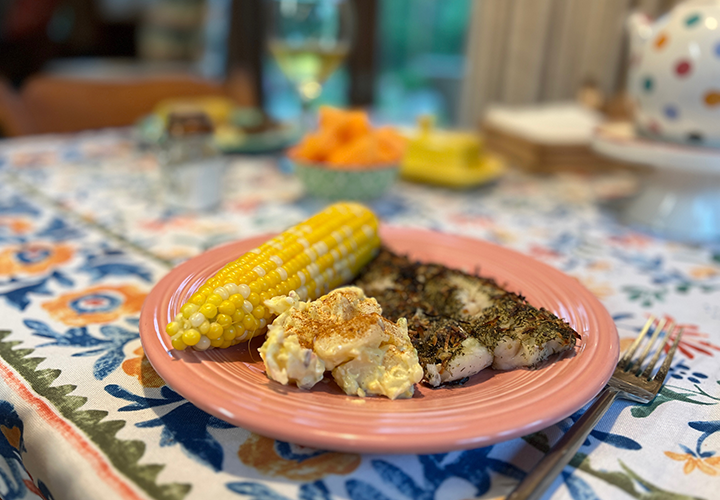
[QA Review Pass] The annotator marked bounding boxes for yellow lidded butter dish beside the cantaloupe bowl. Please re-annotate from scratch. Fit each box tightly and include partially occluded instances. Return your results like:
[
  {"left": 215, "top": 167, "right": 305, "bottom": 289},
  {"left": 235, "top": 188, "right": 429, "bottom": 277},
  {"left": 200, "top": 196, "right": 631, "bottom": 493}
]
[{"left": 400, "top": 116, "right": 505, "bottom": 188}]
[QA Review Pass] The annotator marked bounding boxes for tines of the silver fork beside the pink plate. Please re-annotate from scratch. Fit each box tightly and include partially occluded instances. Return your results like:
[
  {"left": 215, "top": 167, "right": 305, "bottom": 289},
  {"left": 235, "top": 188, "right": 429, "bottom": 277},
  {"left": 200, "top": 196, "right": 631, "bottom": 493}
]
[{"left": 617, "top": 316, "right": 683, "bottom": 382}]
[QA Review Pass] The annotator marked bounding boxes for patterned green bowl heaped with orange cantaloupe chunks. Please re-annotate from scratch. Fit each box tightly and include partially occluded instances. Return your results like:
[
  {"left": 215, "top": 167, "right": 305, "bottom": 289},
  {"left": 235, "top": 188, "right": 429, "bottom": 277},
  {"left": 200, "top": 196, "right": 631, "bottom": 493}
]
[{"left": 288, "top": 106, "right": 407, "bottom": 200}]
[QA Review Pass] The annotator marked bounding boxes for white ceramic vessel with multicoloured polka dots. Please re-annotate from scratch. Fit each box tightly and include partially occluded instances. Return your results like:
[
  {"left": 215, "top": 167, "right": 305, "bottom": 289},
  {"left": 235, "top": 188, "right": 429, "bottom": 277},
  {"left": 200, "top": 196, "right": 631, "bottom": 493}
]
[{"left": 628, "top": 0, "right": 720, "bottom": 147}]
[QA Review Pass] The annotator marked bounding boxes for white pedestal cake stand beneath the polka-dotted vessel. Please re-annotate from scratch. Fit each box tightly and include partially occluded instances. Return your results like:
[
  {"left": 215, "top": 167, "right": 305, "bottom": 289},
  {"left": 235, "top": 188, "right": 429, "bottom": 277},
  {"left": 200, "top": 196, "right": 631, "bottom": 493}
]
[{"left": 592, "top": 123, "right": 720, "bottom": 243}]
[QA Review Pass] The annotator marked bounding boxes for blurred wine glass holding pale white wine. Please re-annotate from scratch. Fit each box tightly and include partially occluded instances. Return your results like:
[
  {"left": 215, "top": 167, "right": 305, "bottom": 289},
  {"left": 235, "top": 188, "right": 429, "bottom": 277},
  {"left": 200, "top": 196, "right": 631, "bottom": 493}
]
[{"left": 266, "top": 0, "right": 354, "bottom": 127}]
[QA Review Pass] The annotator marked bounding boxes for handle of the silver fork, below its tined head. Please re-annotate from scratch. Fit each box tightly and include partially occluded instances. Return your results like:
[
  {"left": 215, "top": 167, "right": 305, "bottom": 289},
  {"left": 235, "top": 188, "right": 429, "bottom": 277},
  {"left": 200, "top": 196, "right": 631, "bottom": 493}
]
[{"left": 505, "top": 387, "right": 618, "bottom": 500}]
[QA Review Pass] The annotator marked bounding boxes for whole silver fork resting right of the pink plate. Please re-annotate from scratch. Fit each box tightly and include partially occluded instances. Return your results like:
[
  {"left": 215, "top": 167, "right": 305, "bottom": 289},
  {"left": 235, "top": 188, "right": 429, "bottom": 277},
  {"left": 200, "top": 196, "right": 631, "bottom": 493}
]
[{"left": 505, "top": 317, "right": 682, "bottom": 500}]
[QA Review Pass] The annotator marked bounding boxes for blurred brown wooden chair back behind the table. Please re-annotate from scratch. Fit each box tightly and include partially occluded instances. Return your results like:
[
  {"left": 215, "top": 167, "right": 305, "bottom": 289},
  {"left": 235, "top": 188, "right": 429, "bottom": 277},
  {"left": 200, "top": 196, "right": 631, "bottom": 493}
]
[{"left": 0, "top": 70, "right": 257, "bottom": 137}]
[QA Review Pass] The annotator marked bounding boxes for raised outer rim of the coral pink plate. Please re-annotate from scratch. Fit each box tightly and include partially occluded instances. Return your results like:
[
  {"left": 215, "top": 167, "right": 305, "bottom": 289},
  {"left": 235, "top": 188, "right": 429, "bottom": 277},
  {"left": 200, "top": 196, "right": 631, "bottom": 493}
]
[{"left": 139, "top": 224, "right": 619, "bottom": 454}]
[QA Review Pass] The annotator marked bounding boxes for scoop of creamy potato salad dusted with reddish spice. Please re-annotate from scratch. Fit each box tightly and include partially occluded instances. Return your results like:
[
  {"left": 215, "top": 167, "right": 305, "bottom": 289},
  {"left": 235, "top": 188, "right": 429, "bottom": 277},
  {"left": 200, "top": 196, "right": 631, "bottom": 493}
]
[{"left": 260, "top": 287, "right": 423, "bottom": 399}]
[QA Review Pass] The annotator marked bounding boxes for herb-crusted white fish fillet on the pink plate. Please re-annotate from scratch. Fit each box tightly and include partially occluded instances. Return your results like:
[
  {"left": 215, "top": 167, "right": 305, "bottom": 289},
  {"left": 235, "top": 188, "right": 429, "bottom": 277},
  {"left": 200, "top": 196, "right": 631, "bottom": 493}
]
[{"left": 355, "top": 248, "right": 579, "bottom": 386}]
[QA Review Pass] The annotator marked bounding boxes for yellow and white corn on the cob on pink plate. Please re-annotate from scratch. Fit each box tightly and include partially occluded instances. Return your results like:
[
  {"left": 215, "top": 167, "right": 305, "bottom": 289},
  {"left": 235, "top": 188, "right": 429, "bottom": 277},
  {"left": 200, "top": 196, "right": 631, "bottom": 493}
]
[{"left": 165, "top": 203, "right": 380, "bottom": 351}]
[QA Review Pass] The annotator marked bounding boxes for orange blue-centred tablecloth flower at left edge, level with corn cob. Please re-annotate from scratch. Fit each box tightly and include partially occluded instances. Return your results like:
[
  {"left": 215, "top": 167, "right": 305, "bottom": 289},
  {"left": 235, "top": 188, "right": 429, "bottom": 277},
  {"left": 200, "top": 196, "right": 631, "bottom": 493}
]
[{"left": 0, "top": 243, "right": 74, "bottom": 276}]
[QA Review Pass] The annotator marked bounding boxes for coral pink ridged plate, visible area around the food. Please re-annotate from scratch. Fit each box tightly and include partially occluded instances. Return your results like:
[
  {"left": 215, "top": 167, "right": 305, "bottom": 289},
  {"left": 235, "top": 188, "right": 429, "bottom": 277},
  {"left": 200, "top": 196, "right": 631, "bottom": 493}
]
[{"left": 140, "top": 227, "right": 619, "bottom": 453}]
